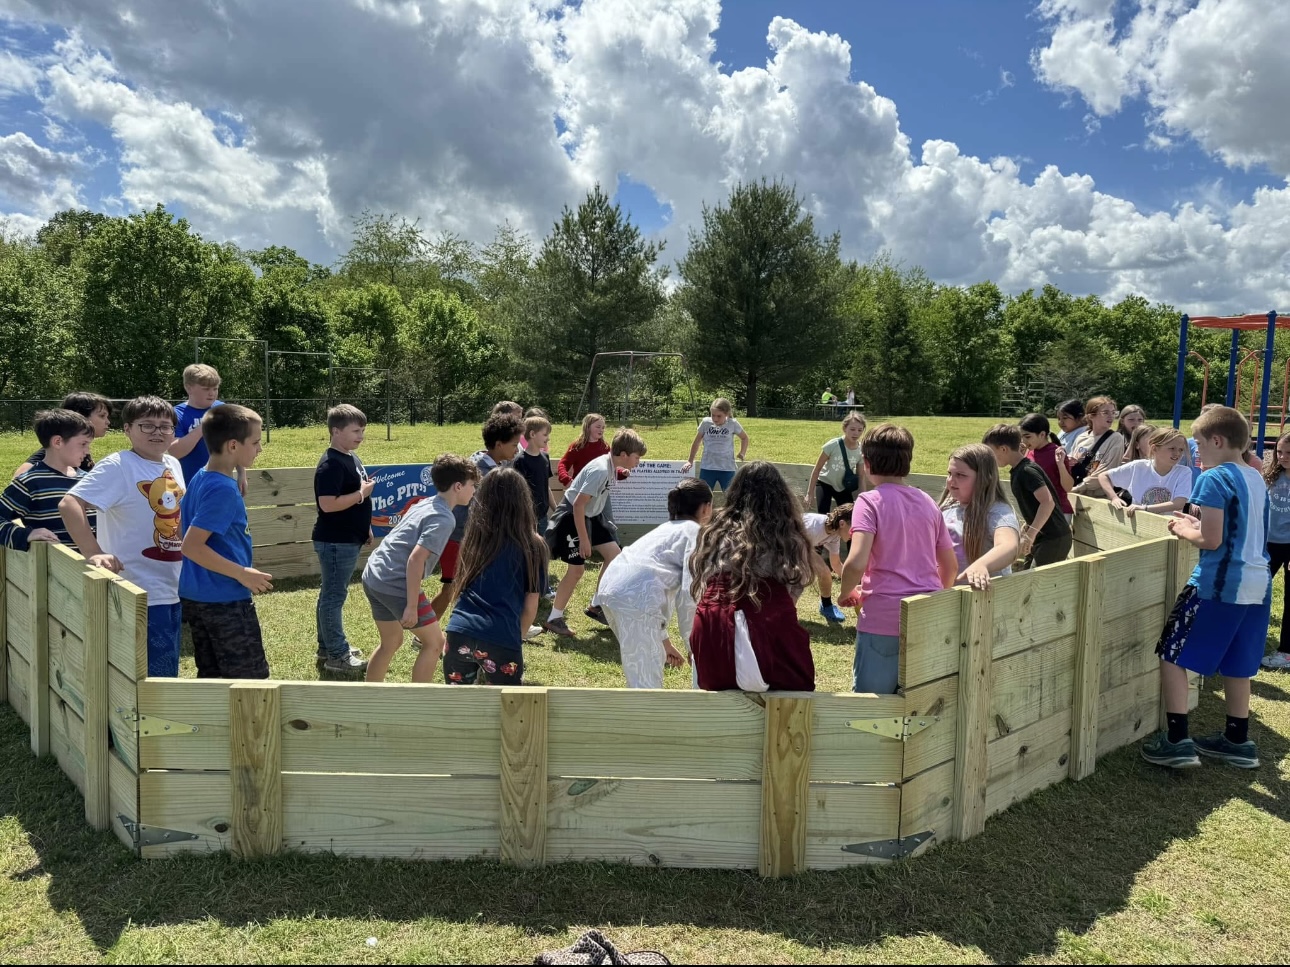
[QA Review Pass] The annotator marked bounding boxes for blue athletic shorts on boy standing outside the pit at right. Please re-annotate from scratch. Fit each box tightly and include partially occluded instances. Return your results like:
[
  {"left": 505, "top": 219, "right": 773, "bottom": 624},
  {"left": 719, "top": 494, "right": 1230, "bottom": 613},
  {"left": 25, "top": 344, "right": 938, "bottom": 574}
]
[{"left": 1156, "top": 584, "right": 1272, "bottom": 678}]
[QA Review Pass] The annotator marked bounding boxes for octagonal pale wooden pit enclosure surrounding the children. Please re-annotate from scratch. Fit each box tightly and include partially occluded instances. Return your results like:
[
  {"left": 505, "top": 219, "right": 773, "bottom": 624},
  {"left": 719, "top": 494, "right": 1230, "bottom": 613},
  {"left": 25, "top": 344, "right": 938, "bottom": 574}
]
[{"left": 0, "top": 465, "right": 1198, "bottom": 877}]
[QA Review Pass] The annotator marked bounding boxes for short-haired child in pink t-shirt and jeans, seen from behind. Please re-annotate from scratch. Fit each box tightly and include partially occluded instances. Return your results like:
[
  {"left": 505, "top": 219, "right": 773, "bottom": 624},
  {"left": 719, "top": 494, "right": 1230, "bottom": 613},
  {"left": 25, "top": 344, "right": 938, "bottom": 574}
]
[{"left": 839, "top": 423, "right": 958, "bottom": 695}]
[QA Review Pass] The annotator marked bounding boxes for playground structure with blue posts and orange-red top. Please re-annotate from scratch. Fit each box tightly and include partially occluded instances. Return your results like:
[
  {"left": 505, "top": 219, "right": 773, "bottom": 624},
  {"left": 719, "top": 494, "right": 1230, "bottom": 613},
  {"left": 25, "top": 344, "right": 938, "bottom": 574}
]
[{"left": 1174, "top": 311, "right": 1290, "bottom": 456}]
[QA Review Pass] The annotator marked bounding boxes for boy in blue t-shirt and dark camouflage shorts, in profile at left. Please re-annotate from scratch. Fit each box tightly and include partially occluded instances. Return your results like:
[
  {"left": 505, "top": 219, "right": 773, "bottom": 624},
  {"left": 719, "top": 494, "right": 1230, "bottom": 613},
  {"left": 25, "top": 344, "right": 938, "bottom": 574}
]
[{"left": 179, "top": 404, "right": 273, "bottom": 678}]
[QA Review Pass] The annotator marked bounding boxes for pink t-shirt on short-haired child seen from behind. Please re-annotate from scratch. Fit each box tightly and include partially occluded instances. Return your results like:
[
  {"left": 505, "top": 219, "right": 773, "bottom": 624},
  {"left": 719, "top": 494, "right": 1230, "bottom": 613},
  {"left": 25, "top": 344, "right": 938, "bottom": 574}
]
[{"left": 851, "top": 484, "right": 953, "bottom": 634}]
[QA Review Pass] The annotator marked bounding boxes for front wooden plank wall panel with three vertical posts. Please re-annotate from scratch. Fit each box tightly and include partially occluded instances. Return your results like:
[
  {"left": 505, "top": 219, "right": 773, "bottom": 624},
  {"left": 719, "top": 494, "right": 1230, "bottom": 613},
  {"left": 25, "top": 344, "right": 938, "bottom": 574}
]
[{"left": 139, "top": 679, "right": 908, "bottom": 875}]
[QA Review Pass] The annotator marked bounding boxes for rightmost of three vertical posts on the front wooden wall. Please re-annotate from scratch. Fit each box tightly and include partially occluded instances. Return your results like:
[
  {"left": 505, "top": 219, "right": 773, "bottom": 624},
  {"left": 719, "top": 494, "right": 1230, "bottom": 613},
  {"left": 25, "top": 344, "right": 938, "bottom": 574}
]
[{"left": 757, "top": 698, "right": 813, "bottom": 877}]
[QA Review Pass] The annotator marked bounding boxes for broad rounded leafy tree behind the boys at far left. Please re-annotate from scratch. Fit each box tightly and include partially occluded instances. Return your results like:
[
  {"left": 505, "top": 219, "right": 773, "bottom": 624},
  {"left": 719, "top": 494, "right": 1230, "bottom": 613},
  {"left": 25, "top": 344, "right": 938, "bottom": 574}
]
[{"left": 72, "top": 205, "right": 255, "bottom": 397}]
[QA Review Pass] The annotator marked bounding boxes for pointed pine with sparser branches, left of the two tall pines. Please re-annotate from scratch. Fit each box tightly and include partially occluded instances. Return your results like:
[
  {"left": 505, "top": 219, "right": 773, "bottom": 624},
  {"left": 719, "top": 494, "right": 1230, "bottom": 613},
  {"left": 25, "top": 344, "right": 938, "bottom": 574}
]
[{"left": 515, "top": 184, "right": 666, "bottom": 407}]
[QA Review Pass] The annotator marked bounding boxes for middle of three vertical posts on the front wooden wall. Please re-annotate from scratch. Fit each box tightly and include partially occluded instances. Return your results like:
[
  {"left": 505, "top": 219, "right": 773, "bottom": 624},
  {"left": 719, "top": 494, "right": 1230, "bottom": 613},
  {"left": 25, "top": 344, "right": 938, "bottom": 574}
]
[{"left": 501, "top": 687, "right": 547, "bottom": 866}]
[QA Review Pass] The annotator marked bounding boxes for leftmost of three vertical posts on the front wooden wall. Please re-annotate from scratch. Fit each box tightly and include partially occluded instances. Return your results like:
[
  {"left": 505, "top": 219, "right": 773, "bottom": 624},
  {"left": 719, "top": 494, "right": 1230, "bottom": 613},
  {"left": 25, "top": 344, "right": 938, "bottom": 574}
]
[{"left": 228, "top": 682, "right": 283, "bottom": 859}]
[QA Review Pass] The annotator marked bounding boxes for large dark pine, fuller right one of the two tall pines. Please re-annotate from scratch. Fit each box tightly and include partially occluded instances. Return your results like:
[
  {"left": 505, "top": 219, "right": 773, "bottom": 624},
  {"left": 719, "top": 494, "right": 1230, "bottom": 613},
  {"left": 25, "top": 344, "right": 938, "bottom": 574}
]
[{"left": 677, "top": 181, "right": 844, "bottom": 416}]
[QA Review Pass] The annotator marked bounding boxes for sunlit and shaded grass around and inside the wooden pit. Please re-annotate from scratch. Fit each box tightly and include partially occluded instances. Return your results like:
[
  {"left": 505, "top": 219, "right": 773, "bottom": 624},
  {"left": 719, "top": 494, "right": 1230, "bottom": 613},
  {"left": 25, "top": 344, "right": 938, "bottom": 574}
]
[{"left": 0, "top": 419, "right": 1290, "bottom": 963}]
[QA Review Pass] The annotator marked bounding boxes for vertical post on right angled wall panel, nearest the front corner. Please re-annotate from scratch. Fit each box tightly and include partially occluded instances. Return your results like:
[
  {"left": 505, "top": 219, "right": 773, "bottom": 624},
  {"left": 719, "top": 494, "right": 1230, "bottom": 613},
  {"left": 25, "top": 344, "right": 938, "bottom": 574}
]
[{"left": 953, "top": 591, "right": 995, "bottom": 839}]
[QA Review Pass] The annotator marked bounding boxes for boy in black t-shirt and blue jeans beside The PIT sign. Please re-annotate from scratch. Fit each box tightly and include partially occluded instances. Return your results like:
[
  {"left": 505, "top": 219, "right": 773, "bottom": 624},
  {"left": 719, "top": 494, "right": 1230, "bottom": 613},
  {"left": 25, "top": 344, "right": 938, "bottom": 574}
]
[{"left": 312, "top": 404, "right": 377, "bottom": 674}]
